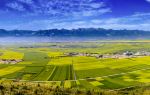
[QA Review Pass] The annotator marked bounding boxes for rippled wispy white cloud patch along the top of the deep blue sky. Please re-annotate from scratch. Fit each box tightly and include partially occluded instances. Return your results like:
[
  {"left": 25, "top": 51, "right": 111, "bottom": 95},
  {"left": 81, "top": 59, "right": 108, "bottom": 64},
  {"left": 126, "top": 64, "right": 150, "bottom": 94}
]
[{"left": 4, "top": 0, "right": 111, "bottom": 18}]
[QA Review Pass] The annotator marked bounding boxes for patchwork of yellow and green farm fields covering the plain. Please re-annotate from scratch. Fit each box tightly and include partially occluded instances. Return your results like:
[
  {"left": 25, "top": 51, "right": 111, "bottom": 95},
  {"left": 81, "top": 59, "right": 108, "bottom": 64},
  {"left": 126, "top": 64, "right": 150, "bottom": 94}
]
[{"left": 0, "top": 43, "right": 150, "bottom": 89}]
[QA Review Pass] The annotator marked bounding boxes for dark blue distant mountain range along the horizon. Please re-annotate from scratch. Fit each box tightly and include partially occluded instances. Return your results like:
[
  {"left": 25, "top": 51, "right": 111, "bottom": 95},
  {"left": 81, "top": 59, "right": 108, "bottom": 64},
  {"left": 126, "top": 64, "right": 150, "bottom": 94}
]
[{"left": 0, "top": 28, "right": 150, "bottom": 37}]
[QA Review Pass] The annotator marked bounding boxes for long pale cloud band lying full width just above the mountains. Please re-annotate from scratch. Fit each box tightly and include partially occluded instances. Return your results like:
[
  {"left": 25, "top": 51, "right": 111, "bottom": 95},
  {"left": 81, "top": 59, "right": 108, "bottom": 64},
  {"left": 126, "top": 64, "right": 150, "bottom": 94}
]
[{"left": 0, "top": 13, "right": 150, "bottom": 31}]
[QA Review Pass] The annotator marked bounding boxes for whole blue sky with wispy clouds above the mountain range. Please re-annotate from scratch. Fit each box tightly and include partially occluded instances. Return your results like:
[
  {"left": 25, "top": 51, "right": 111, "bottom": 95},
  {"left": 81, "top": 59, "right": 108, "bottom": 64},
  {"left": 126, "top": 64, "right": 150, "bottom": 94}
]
[{"left": 0, "top": 0, "right": 150, "bottom": 31}]
